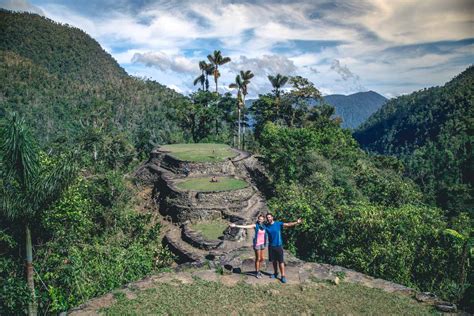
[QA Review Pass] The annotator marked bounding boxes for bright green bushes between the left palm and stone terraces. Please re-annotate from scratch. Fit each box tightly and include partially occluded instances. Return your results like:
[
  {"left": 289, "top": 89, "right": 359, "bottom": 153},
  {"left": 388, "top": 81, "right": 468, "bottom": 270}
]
[{"left": 32, "top": 173, "right": 173, "bottom": 312}]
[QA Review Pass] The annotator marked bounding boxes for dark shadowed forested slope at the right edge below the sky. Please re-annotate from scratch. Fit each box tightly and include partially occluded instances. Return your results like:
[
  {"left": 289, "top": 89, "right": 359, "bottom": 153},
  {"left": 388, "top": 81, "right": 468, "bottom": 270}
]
[{"left": 354, "top": 66, "right": 474, "bottom": 213}]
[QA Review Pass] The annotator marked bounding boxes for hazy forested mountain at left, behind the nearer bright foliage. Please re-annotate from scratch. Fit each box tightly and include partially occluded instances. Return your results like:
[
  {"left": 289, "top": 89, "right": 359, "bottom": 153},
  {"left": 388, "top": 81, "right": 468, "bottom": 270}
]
[{"left": 0, "top": 9, "right": 184, "bottom": 151}]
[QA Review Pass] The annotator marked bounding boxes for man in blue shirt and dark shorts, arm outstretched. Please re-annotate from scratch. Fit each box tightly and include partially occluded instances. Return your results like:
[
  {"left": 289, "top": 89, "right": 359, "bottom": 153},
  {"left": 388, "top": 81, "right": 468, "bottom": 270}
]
[{"left": 266, "top": 213, "right": 301, "bottom": 283}]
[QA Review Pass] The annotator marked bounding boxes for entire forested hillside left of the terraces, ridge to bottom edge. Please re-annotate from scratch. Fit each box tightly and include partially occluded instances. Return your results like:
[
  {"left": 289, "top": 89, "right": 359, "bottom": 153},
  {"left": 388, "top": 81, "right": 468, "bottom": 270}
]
[{"left": 0, "top": 10, "right": 186, "bottom": 315}]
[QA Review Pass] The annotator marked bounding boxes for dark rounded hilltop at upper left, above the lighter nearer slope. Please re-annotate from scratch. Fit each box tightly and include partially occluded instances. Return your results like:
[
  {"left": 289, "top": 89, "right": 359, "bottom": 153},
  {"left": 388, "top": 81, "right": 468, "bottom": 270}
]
[{"left": 0, "top": 10, "right": 127, "bottom": 81}]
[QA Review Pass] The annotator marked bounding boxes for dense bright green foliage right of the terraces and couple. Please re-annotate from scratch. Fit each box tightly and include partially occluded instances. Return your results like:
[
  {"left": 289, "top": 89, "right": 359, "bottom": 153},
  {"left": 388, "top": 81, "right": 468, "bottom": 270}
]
[{"left": 260, "top": 115, "right": 469, "bottom": 301}]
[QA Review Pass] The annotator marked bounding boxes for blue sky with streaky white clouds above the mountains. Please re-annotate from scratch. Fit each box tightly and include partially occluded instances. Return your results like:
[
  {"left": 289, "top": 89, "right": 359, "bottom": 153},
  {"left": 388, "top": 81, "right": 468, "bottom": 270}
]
[{"left": 0, "top": 0, "right": 474, "bottom": 98}]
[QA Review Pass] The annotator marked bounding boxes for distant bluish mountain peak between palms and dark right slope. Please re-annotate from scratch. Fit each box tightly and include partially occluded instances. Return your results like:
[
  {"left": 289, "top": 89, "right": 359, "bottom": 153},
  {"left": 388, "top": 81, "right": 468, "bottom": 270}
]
[{"left": 324, "top": 91, "right": 387, "bottom": 128}]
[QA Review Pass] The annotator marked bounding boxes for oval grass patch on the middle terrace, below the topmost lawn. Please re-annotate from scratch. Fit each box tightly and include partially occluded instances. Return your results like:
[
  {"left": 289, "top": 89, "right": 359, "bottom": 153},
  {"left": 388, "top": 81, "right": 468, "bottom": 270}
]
[{"left": 176, "top": 177, "right": 248, "bottom": 192}]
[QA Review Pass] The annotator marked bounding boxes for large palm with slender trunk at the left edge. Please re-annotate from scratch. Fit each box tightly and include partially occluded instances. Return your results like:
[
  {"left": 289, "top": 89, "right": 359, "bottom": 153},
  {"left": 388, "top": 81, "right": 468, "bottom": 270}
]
[{"left": 0, "top": 113, "right": 75, "bottom": 315}]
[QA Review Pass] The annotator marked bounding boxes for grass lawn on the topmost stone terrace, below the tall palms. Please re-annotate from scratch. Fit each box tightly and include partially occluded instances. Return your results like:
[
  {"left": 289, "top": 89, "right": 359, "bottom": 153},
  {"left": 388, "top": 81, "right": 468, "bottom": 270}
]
[{"left": 161, "top": 144, "right": 237, "bottom": 162}]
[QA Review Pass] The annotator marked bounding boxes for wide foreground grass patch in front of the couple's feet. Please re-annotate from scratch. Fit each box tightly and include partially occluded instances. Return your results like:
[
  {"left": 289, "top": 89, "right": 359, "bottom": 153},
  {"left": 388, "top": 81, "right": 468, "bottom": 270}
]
[{"left": 102, "top": 280, "right": 436, "bottom": 315}]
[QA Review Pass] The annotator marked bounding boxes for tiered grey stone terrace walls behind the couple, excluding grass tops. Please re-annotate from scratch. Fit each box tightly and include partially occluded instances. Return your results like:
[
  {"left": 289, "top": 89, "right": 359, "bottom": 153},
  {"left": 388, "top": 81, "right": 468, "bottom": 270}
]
[{"left": 136, "top": 147, "right": 268, "bottom": 262}]
